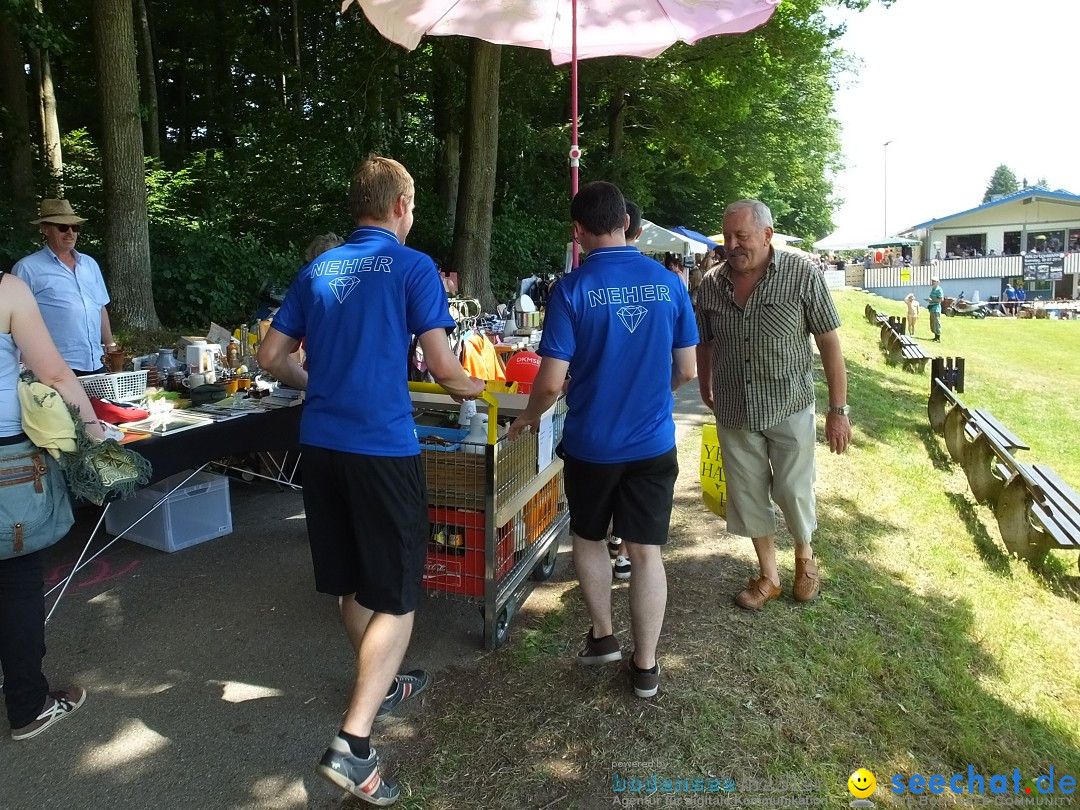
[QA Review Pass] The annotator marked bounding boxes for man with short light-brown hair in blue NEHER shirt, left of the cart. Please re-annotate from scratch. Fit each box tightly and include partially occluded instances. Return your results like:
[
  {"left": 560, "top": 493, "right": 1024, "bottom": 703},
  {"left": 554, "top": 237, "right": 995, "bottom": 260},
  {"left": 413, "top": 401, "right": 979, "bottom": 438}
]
[{"left": 258, "top": 157, "right": 485, "bottom": 805}]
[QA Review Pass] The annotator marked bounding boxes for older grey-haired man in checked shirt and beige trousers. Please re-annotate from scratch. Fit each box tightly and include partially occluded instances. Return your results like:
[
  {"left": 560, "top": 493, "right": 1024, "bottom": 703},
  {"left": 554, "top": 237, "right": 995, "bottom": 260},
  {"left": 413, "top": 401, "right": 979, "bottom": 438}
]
[{"left": 697, "top": 200, "right": 851, "bottom": 610}]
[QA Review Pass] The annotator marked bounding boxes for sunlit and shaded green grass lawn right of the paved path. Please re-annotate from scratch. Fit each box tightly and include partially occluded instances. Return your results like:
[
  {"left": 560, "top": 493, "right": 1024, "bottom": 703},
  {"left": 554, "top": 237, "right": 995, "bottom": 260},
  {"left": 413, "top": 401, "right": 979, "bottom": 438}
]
[{"left": 390, "top": 291, "right": 1080, "bottom": 810}]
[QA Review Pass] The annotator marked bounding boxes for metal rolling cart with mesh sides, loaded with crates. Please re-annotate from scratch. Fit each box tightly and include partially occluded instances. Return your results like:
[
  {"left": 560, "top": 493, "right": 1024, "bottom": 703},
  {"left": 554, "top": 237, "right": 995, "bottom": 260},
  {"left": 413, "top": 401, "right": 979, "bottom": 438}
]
[{"left": 409, "top": 382, "right": 570, "bottom": 650}]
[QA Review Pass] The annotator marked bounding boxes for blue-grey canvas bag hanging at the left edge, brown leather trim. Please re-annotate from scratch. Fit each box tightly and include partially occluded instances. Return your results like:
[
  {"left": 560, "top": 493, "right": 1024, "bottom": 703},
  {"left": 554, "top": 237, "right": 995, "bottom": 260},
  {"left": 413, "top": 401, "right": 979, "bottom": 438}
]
[{"left": 0, "top": 440, "right": 75, "bottom": 559}]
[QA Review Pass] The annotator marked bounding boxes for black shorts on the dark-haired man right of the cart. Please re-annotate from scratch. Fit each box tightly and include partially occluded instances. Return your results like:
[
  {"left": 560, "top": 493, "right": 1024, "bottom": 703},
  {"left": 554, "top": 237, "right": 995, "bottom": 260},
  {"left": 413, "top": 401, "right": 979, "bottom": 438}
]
[{"left": 559, "top": 447, "right": 678, "bottom": 545}]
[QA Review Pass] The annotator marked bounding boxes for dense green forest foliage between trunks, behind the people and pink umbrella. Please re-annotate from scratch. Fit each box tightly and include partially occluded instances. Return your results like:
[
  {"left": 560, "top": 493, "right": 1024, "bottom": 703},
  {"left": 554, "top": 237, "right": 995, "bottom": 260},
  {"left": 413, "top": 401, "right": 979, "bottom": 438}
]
[{"left": 0, "top": 0, "right": 868, "bottom": 323}]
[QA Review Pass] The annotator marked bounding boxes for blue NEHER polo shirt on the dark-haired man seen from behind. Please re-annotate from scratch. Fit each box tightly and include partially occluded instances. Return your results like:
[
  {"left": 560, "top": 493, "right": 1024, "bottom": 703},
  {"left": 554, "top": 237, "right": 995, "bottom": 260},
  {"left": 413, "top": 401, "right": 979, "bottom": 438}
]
[{"left": 539, "top": 247, "right": 698, "bottom": 463}]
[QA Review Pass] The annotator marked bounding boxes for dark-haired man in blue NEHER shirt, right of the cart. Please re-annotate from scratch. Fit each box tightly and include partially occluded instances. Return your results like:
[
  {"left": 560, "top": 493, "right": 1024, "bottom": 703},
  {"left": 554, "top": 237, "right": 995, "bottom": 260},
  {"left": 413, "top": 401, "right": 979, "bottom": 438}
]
[{"left": 509, "top": 183, "right": 698, "bottom": 698}]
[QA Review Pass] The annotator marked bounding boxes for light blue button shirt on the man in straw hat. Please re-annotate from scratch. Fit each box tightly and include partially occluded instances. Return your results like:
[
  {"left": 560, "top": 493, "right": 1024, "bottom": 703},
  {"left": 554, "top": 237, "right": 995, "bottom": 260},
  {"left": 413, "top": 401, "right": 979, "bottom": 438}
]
[{"left": 12, "top": 247, "right": 109, "bottom": 372}]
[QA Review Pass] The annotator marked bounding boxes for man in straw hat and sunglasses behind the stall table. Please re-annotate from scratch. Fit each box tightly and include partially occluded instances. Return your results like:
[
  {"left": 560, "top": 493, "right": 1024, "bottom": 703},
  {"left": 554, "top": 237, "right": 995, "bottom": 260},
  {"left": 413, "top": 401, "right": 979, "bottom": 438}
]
[{"left": 12, "top": 200, "right": 116, "bottom": 376}]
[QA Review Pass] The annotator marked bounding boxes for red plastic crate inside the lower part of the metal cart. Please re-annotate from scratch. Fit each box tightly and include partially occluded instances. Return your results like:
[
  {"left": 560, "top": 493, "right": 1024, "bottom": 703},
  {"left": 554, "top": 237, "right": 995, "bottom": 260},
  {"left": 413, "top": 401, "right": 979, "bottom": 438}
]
[{"left": 423, "top": 507, "right": 514, "bottom": 596}]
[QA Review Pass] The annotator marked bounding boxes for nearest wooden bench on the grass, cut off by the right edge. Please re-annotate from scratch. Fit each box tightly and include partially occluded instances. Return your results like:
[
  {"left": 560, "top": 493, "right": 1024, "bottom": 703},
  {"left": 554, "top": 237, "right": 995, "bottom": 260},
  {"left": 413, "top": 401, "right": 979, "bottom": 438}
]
[{"left": 927, "top": 359, "right": 1080, "bottom": 558}]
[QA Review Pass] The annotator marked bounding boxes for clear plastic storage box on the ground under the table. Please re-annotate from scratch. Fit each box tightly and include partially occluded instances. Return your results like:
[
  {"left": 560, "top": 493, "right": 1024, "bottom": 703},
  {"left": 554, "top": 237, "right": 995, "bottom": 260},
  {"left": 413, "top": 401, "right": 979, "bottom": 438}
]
[{"left": 105, "top": 470, "right": 232, "bottom": 552}]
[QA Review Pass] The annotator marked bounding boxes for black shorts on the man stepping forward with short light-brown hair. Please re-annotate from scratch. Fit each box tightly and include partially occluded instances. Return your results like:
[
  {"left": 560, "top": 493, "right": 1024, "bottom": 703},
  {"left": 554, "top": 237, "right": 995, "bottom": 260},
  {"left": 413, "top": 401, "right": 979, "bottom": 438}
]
[{"left": 301, "top": 445, "right": 428, "bottom": 616}]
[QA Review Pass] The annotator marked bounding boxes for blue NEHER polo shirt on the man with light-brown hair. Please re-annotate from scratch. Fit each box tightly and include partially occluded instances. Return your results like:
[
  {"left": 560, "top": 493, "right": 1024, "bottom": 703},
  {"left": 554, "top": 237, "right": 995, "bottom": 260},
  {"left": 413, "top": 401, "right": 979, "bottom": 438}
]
[{"left": 273, "top": 227, "right": 454, "bottom": 456}]
